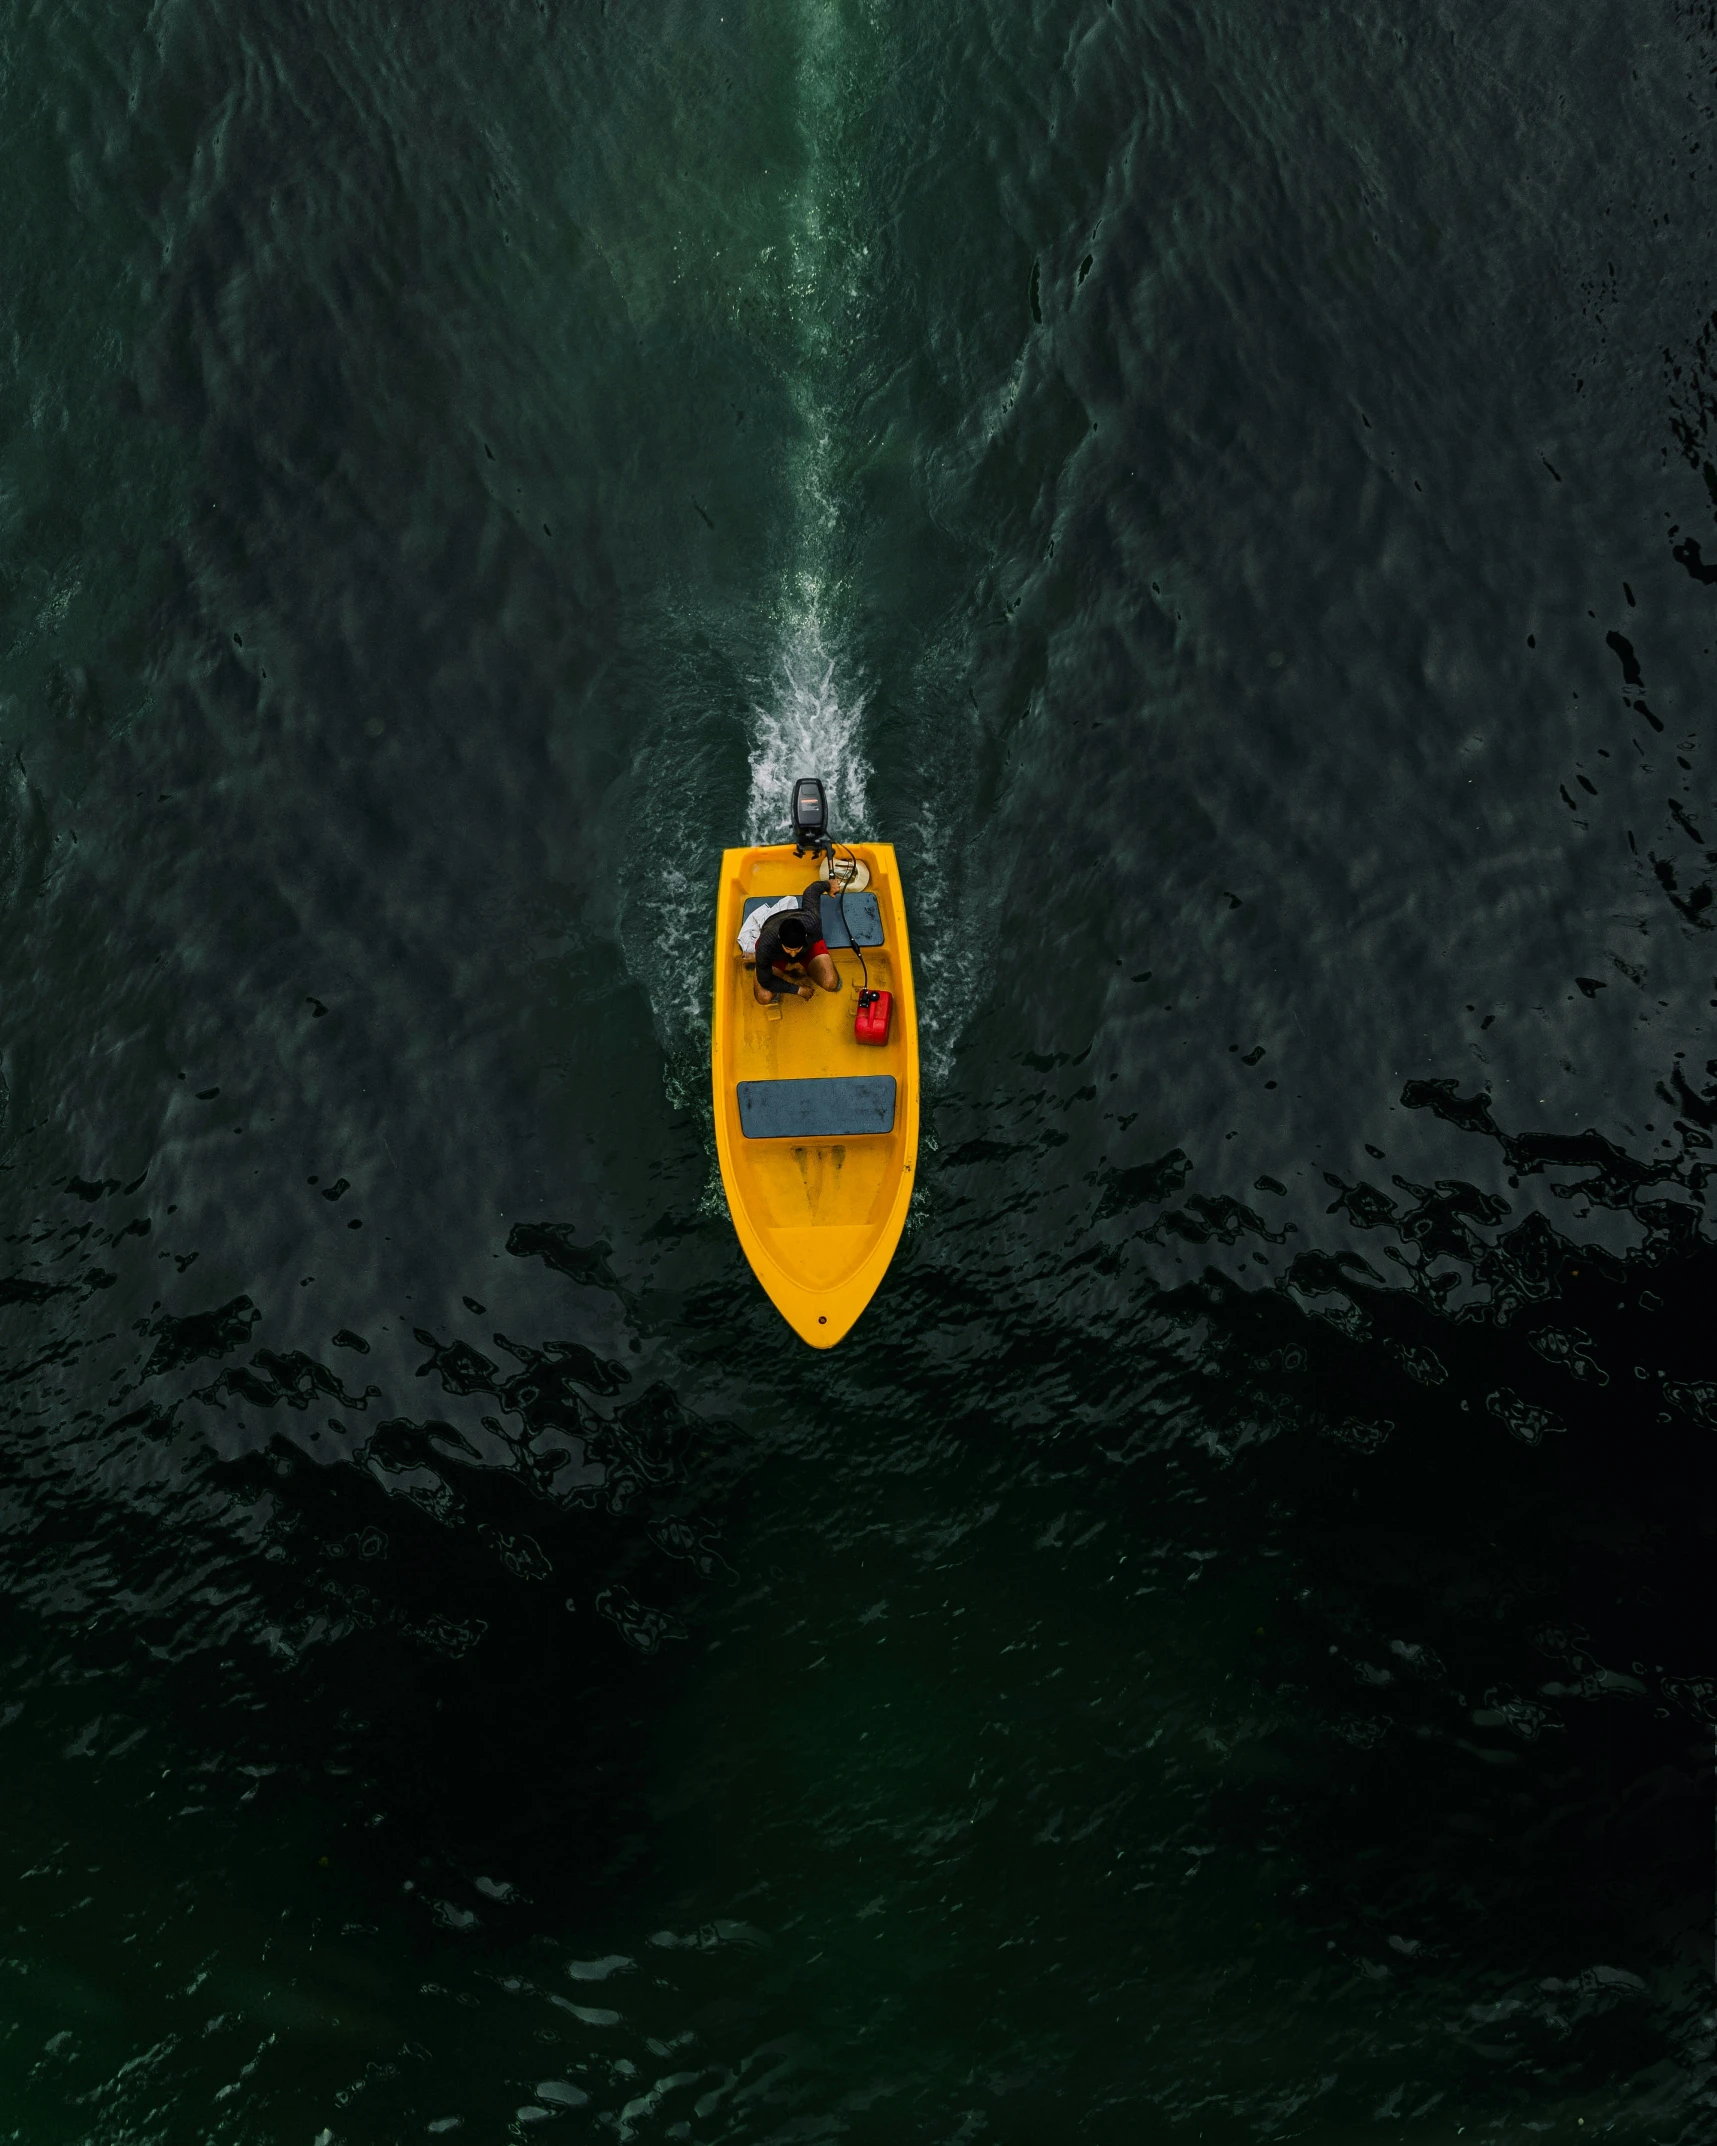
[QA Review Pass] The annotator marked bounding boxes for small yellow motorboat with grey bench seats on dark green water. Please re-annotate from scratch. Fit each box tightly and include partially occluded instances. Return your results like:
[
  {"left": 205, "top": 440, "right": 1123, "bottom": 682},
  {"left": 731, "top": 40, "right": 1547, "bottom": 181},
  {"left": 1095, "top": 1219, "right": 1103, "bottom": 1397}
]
[{"left": 710, "top": 841, "right": 919, "bottom": 1348}]
